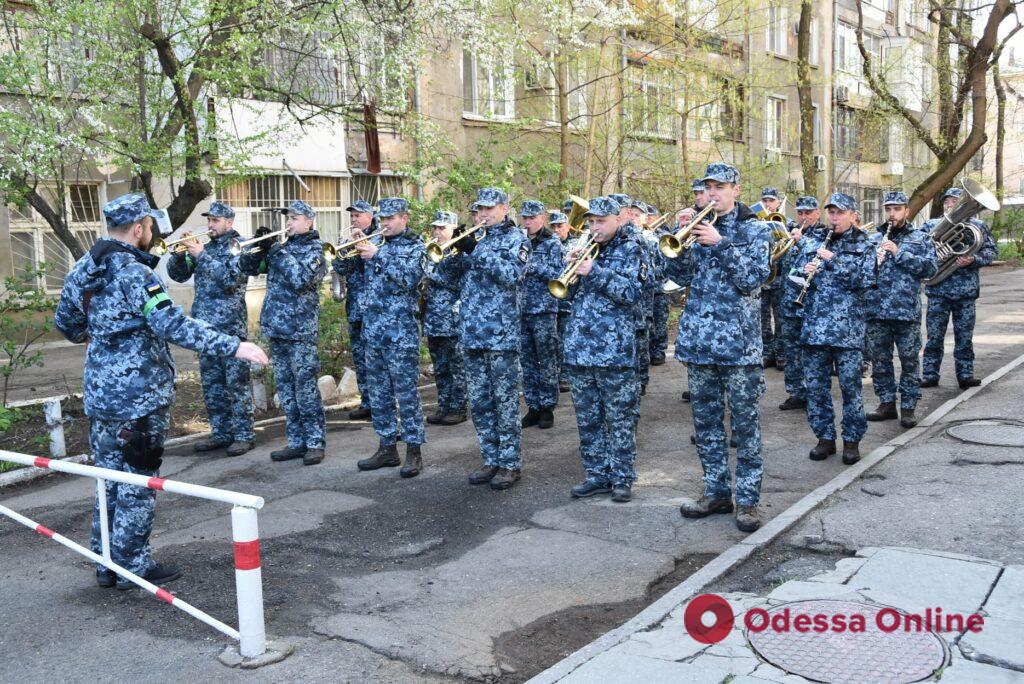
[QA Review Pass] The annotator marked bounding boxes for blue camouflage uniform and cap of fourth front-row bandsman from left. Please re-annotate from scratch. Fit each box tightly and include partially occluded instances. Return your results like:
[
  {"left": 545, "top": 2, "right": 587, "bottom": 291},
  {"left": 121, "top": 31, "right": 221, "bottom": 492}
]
[{"left": 437, "top": 188, "right": 529, "bottom": 470}]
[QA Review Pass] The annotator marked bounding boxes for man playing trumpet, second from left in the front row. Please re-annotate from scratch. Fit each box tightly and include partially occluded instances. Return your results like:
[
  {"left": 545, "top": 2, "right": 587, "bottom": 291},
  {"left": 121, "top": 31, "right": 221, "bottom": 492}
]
[{"left": 241, "top": 200, "right": 327, "bottom": 466}]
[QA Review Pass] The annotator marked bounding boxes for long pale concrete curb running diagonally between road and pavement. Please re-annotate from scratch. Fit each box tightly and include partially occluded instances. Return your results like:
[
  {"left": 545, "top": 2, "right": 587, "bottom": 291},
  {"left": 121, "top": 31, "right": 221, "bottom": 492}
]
[{"left": 526, "top": 354, "right": 1024, "bottom": 684}]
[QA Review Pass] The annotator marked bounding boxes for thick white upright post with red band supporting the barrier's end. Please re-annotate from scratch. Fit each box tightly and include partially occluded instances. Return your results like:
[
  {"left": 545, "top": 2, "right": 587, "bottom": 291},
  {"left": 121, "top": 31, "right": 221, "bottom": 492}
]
[{"left": 231, "top": 506, "right": 266, "bottom": 657}]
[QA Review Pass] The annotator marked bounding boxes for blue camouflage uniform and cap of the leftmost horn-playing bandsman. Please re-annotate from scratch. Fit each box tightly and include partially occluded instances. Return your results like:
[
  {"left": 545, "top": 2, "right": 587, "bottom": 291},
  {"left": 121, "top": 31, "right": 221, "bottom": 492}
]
[{"left": 167, "top": 210, "right": 256, "bottom": 441}]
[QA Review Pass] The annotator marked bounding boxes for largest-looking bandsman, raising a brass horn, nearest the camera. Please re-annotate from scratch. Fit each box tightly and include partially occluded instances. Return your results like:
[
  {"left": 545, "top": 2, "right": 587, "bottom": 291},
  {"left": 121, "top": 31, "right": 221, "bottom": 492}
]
[{"left": 666, "top": 163, "right": 770, "bottom": 531}]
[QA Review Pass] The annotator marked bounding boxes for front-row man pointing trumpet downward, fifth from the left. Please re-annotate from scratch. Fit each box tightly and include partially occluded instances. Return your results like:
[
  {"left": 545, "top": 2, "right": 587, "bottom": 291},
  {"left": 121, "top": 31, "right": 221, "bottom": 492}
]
[{"left": 564, "top": 197, "right": 642, "bottom": 502}]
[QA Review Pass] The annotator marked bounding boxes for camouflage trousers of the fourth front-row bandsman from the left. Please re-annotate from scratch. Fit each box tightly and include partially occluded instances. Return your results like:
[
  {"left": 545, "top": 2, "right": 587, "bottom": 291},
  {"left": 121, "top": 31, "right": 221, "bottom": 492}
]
[{"left": 465, "top": 349, "right": 522, "bottom": 470}]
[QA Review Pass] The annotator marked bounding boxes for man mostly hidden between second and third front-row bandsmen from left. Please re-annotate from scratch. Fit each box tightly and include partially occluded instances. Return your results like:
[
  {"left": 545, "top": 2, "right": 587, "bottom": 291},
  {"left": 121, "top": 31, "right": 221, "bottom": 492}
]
[{"left": 332, "top": 200, "right": 378, "bottom": 421}]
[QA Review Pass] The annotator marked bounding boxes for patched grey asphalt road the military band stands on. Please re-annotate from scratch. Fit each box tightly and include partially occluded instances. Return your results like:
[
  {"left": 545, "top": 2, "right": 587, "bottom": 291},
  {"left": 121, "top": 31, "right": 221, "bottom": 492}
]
[{"left": 0, "top": 269, "right": 1024, "bottom": 682}]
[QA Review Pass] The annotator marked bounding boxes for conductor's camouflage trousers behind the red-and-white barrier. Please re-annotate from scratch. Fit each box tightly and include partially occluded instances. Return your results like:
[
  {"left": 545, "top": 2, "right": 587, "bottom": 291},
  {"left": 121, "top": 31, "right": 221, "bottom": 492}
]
[{"left": 89, "top": 407, "right": 171, "bottom": 574}]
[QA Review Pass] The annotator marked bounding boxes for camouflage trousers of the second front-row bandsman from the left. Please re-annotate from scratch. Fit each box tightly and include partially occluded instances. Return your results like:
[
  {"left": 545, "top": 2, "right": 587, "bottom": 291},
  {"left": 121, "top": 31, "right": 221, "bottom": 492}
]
[{"left": 270, "top": 339, "right": 326, "bottom": 448}]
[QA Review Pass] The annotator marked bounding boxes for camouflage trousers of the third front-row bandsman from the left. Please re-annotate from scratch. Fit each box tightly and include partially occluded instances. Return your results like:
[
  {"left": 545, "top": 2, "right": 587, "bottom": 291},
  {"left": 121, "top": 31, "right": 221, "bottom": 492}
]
[{"left": 366, "top": 344, "right": 426, "bottom": 446}]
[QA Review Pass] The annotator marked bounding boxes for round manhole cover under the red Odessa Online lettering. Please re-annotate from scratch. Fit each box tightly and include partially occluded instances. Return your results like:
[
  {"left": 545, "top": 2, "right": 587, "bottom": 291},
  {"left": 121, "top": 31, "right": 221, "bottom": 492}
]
[{"left": 745, "top": 600, "right": 946, "bottom": 684}]
